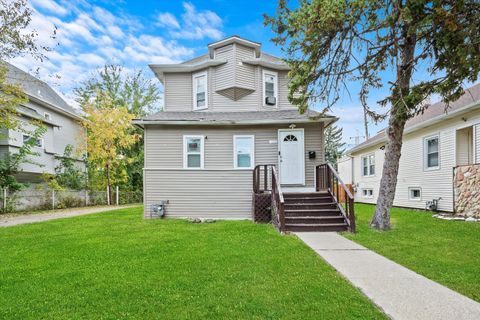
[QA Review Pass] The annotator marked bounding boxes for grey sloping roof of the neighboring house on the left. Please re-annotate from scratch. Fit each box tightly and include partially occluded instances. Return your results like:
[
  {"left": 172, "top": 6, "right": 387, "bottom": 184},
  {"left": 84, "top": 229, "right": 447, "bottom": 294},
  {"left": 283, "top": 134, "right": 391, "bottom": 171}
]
[{"left": 4, "top": 62, "right": 79, "bottom": 117}]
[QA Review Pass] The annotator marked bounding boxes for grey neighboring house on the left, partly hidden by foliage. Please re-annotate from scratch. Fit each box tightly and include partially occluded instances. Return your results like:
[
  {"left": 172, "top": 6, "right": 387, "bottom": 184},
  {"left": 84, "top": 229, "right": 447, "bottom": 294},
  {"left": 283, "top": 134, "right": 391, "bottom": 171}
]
[{"left": 0, "top": 63, "right": 85, "bottom": 183}]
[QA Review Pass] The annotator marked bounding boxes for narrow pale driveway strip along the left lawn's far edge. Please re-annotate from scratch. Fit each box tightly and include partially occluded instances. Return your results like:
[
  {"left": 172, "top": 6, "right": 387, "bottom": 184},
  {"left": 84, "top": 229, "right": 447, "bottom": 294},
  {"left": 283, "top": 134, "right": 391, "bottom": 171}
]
[{"left": 0, "top": 205, "right": 138, "bottom": 227}]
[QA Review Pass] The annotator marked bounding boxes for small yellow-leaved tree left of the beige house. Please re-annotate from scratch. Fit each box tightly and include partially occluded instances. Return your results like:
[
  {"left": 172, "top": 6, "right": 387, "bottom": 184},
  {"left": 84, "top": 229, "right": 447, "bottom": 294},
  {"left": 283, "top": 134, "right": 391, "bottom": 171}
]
[{"left": 83, "top": 94, "right": 140, "bottom": 203}]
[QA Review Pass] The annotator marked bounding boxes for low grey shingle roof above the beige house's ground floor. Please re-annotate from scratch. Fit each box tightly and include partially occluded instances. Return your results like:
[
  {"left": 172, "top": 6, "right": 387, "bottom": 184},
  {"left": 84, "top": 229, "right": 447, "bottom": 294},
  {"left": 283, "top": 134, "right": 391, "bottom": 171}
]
[{"left": 137, "top": 110, "right": 335, "bottom": 123}]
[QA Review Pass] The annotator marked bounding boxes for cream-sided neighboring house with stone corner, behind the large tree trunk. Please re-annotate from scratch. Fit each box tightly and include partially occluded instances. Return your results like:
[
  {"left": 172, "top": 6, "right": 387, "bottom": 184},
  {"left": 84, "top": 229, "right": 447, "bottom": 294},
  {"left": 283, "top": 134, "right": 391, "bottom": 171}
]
[{"left": 339, "top": 84, "right": 480, "bottom": 215}]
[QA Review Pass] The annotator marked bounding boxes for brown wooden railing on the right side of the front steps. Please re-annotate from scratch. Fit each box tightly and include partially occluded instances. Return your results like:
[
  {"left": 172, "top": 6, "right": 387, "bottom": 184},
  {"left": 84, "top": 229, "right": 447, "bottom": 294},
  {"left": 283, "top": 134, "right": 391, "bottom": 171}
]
[{"left": 315, "top": 163, "right": 356, "bottom": 232}]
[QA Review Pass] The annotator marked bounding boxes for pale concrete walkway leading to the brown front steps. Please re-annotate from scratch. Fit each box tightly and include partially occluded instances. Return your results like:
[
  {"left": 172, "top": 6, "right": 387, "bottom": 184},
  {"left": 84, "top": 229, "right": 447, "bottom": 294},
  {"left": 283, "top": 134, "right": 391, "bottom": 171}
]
[{"left": 296, "top": 232, "right": 480, "bottom": 320}]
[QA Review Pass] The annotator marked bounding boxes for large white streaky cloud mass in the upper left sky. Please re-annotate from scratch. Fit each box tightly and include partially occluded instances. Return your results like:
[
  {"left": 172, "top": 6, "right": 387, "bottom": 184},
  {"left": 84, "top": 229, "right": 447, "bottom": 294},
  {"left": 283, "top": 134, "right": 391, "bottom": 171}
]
[{"left": 6, "top": 0, "right": 198, "bottom": 102}]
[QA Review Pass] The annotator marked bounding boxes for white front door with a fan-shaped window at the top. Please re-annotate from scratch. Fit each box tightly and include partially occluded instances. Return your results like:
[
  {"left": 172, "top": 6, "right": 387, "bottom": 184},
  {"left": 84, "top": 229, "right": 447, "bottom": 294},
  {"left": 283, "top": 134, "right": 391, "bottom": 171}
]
[{"left": 278, "top": 129, "right": 305, "bottom": 185}]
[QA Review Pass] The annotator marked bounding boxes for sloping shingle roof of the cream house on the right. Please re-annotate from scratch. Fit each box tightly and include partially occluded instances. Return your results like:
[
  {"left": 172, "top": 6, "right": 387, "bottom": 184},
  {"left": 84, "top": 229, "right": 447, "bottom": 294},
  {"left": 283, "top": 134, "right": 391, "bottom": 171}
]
[{"left": 347, "top": 83, "right": 480, "bottom": 153}]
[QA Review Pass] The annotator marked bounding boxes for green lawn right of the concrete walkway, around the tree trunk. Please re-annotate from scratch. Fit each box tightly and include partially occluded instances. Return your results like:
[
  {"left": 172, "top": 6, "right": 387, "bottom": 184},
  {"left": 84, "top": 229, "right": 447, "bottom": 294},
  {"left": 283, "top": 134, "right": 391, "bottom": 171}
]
[{"left": 345, "top": 204, "right": 480, "bottom": 302}]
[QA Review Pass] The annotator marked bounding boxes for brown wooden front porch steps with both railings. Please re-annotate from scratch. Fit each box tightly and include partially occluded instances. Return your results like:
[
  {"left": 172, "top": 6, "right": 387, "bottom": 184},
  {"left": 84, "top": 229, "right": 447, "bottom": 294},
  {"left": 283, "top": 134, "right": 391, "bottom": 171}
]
[{"left": 252, "top": 164, "right": 355, "bottom": 232}]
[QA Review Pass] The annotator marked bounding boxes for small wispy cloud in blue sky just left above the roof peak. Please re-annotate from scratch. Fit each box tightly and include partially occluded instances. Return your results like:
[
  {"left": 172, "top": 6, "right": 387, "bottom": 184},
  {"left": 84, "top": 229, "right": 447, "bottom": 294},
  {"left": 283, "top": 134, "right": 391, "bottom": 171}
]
[{"left": 158, "top": 2, "right": 223, "bottom": 40}]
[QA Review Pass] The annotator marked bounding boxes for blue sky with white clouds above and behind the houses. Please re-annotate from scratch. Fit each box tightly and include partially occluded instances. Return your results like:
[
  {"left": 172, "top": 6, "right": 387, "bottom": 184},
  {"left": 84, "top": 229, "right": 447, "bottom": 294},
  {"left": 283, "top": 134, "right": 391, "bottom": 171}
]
[{"left": 11, "top": 0, "right": 392, "bottom": 146}]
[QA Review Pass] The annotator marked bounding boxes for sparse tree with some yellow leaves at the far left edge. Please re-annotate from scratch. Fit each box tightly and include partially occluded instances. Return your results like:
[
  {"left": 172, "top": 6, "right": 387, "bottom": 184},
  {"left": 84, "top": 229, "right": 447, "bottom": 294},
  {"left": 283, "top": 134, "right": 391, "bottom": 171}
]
[{"left": 0, "top": 0, "right": 56, "bottom": 129}]
